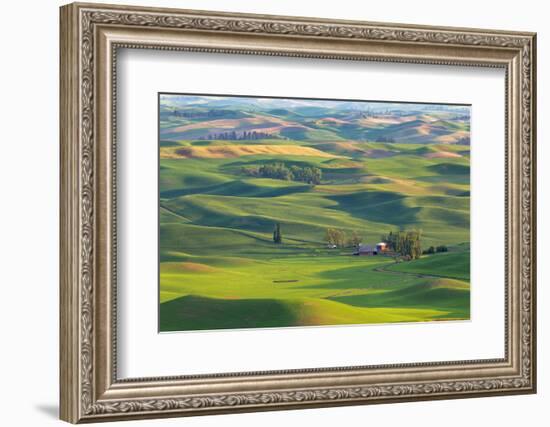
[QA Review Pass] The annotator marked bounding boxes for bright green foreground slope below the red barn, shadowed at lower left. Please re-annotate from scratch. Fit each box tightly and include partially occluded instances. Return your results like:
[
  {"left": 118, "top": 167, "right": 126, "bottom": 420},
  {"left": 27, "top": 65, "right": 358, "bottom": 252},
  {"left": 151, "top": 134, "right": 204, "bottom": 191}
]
[{"left": 161, "top": 256, "right": 469, "bottom": 330}]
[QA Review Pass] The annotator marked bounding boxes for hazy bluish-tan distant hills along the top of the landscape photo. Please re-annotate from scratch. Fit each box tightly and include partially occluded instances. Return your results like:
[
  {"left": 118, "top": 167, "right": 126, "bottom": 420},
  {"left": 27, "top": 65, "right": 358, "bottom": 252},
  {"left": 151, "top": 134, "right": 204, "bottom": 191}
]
[{"left": 160, "top": 95, "right": 470, "bottom": 144}]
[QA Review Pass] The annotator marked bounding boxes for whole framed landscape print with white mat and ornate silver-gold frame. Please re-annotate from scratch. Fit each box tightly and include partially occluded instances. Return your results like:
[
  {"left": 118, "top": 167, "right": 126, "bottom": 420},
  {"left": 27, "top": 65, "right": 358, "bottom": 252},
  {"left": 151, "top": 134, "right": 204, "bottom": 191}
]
[{"left": 60, "top": 4, "right": 536, "bottom": 423}]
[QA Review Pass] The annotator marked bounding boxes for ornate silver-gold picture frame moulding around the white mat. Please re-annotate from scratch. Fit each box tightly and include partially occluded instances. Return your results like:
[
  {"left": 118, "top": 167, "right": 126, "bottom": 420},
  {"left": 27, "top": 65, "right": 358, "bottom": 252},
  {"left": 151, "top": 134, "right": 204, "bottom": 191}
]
[{"left": 60, "top": 3, "right": 536, "bottom": 423}]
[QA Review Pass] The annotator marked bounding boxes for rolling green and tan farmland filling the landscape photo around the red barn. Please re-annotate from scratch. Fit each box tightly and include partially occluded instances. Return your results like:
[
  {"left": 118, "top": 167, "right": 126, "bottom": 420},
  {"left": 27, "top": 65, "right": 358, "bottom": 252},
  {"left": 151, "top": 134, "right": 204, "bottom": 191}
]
[{"left": 159, "top": 94, "right": 470, "bottom": 331}]
